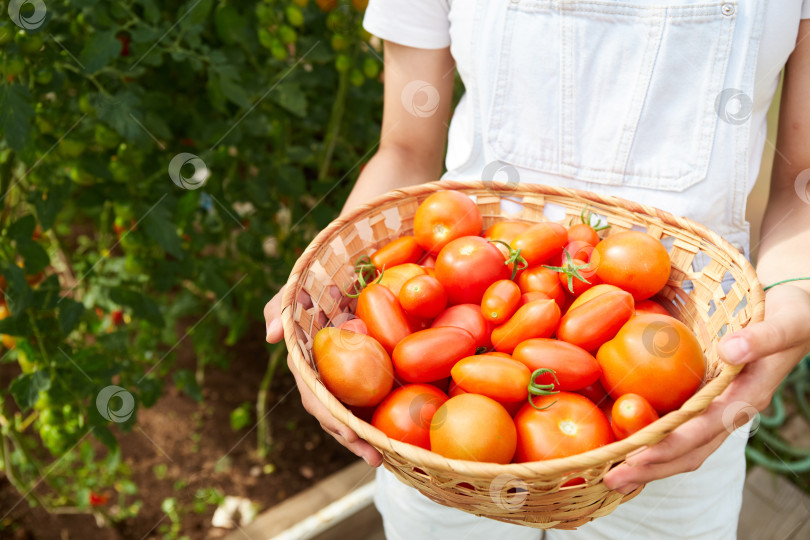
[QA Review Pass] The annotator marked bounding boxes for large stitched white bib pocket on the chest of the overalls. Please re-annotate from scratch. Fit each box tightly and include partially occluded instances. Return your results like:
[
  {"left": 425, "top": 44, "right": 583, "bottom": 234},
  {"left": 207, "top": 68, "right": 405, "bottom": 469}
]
[{"left": 487, "top": 0, "right": 737, "bottom": 191}]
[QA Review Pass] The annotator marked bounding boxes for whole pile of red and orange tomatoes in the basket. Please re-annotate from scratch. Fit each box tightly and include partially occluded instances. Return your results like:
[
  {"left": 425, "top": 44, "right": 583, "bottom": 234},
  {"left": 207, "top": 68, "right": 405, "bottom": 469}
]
[{"left": 313, "top": 191, "right": 706, "bottom": 463}]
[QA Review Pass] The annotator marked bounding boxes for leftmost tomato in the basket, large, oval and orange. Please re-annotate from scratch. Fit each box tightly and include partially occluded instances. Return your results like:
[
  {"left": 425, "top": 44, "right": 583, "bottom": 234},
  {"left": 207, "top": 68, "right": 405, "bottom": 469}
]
[{"left": 312, "top": 327, "right": 394, "bottom": 407}]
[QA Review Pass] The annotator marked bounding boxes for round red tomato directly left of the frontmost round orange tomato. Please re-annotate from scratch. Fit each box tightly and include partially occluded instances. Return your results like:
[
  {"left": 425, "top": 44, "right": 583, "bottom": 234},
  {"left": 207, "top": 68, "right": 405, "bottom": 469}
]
[{"left": 371, "top": 384, "right": 447, "bottom": 450}]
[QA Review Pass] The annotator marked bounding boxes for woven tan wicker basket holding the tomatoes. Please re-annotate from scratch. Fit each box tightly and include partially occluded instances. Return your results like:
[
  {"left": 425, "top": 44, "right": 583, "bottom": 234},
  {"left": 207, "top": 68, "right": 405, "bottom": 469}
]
[{"left": 282, "top": 181, "right": 764, "bottom": 529}]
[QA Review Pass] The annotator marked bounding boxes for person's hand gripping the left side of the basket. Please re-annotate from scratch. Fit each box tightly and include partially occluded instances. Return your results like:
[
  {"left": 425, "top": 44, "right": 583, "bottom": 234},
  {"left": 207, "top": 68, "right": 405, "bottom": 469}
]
[{"left": 264, "top": 287, "right": 382, "bottom": 467}]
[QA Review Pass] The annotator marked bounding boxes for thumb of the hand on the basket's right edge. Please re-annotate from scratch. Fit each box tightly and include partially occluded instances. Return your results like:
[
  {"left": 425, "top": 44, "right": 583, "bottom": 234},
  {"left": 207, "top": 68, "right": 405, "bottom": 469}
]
[{"left": 718, "top": 313, "right": 801, "bottom": 364}]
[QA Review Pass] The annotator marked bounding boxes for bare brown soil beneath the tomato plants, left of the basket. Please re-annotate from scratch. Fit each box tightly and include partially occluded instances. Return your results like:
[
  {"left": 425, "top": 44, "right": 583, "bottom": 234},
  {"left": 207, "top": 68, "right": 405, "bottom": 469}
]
[{"left": 0, "top": 329, "right": 356, "bottom": 540}]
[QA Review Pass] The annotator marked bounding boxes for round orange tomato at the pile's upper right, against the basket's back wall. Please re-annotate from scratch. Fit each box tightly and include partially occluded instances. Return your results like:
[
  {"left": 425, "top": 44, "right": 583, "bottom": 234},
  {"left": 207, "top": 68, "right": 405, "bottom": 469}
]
[{"left": 596, "top": 231, "right": 670, "bottom": 301}]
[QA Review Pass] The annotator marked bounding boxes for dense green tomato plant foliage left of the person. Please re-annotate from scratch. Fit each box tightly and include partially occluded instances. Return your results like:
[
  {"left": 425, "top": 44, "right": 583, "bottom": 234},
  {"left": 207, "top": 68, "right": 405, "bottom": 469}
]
[{"left": 0, "top": 0, "right": 381, "bottom": 520}]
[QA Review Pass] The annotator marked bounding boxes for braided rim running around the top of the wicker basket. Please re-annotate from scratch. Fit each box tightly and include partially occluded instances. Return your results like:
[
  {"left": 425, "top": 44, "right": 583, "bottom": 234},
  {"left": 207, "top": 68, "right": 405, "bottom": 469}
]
[{"left": 281, "top": 180, "right": 765, "bottom": 479}]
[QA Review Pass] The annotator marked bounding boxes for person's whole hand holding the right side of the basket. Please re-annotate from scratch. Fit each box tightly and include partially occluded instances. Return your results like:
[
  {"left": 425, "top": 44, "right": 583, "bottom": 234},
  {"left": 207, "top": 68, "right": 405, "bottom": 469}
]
[{"left": 605, "top": 284, "right": 810, "bottom": 494}]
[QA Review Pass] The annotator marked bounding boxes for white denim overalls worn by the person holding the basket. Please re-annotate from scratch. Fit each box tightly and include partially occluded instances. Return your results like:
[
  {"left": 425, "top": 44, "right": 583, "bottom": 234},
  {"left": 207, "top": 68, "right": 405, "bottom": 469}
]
[{"left": 375, "top": 0, "right": 772, "bottom": 540}]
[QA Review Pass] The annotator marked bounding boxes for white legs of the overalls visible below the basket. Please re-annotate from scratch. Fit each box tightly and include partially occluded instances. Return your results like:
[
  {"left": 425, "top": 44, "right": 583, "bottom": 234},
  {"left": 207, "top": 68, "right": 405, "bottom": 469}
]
[{"left": 374, "top": 425, "right": 749, "bottom": 540}]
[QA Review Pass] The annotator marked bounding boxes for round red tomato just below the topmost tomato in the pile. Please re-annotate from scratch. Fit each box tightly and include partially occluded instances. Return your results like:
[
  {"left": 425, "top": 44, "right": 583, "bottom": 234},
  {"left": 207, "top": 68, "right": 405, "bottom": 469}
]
[{"left": 436, "top": 236, "right": 504, "bottom": 305}]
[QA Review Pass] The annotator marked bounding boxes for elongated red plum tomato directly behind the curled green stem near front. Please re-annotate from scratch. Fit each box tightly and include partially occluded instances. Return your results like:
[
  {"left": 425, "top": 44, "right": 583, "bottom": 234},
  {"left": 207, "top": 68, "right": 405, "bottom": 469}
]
[{"left": 512, "top": 338, "right": 602, "bottom": 392}]
